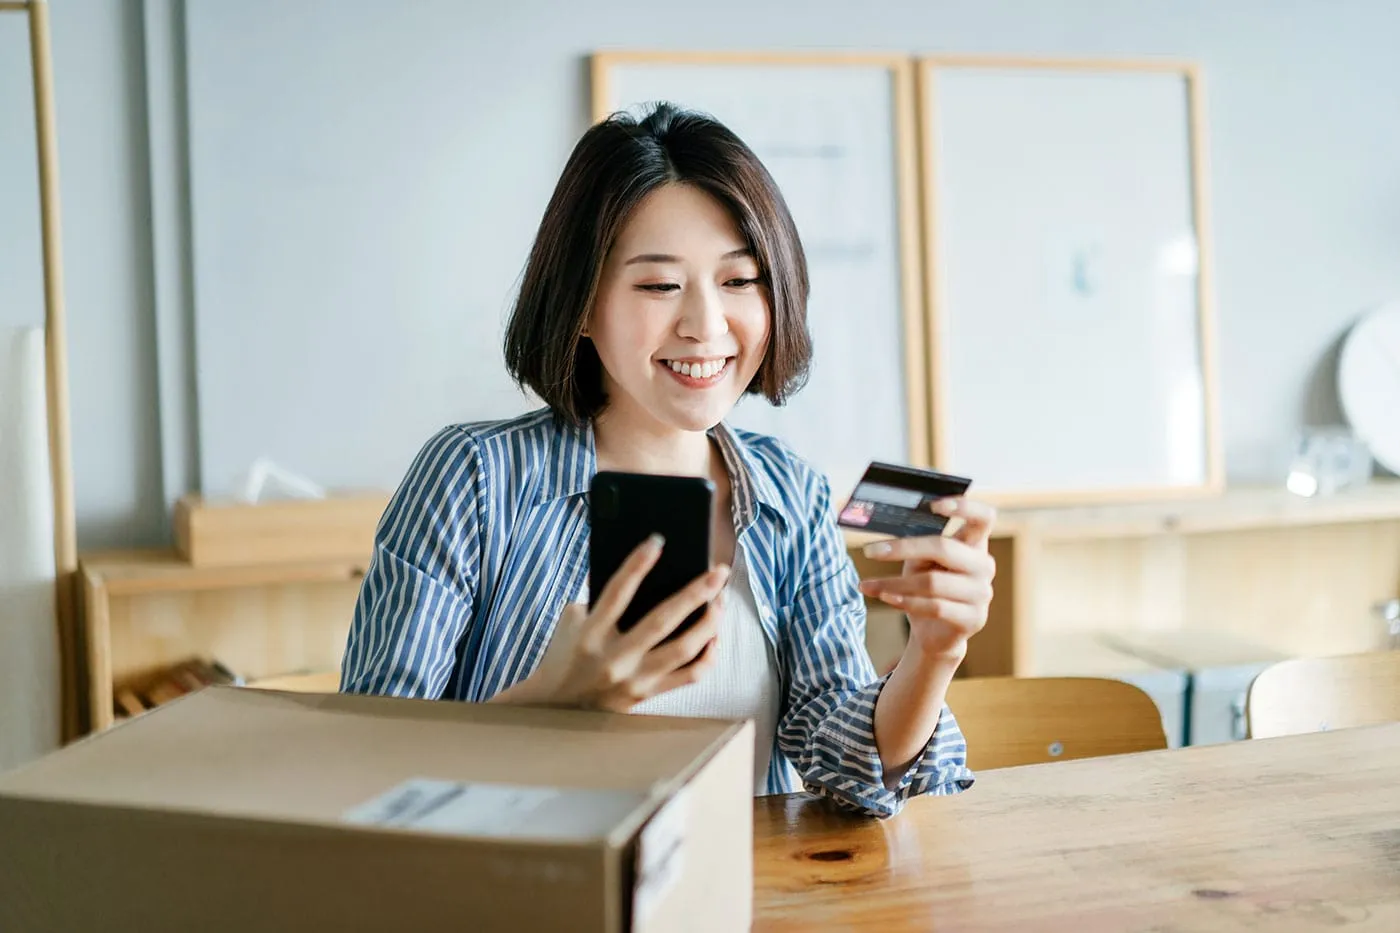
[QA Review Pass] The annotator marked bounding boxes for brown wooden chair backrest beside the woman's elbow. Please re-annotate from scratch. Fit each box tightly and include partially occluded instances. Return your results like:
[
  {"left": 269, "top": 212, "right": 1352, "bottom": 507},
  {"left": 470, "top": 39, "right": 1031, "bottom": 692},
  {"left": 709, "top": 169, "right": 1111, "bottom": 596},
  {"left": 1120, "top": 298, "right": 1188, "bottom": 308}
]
[{"left": 948, "top": 677, "right": 1166, "bottom": 770}]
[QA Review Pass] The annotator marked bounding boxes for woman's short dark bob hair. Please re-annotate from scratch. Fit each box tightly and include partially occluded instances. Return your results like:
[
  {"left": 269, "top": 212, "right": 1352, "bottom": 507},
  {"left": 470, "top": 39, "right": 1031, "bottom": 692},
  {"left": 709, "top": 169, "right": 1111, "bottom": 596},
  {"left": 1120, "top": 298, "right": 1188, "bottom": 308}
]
[{"left": 505, "top": 104, "right": 812, "bottom": 424}]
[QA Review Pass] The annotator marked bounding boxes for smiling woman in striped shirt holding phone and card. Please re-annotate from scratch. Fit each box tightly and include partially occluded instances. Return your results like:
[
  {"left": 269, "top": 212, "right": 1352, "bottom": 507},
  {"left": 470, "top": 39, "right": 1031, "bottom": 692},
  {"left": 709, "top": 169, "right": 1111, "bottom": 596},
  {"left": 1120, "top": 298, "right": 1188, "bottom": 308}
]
[{"left": 342, "top": 105, "right": 994, "bottom": 817}]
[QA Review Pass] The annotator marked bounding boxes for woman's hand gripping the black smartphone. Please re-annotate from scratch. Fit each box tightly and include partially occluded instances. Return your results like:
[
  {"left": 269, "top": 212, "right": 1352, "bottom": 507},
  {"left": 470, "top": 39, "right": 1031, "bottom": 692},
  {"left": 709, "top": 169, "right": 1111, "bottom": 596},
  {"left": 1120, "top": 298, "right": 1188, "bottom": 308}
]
[{"left": 497, "top": 535, "right": 729, "bottom": 712}]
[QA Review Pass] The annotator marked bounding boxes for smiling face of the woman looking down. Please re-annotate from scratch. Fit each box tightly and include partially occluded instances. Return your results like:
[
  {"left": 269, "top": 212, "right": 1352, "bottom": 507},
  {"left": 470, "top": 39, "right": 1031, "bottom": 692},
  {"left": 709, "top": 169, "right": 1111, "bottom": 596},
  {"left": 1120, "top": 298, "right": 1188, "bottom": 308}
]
[{"left": 587, "top": 184, "right": 771, "bottom": 431}]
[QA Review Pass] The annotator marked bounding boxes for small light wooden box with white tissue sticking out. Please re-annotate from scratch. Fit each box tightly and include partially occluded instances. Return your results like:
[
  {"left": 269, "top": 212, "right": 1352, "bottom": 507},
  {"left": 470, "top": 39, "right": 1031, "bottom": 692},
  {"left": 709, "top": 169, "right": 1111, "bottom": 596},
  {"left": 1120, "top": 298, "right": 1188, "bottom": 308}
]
[{"left": 175, "top": 492, "right": 389, "bottom": 567}]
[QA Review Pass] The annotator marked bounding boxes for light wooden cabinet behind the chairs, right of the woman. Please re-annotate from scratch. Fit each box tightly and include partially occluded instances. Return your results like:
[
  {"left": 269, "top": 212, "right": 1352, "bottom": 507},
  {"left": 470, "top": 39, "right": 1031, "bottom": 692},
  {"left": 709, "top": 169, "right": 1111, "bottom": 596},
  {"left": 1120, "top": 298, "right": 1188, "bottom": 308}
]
[{"left": 850, "top": 481, "right": 1400, "bottom": 675}]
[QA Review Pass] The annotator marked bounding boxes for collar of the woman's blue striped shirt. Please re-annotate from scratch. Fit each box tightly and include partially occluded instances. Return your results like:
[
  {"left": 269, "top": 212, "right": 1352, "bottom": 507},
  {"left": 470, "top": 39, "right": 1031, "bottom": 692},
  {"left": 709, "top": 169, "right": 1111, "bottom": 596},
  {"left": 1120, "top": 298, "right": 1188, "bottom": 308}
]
[{"left": 540, "top": 422, "right": 785, "bottom": 528}]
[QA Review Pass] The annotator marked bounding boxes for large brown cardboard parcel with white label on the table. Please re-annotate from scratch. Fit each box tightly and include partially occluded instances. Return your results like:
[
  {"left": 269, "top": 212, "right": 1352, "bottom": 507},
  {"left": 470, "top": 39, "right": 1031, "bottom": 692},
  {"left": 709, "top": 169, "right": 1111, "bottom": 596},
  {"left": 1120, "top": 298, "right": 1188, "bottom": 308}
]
[{"left": 0, "top": 686, "right": 753, "bottom": 933}]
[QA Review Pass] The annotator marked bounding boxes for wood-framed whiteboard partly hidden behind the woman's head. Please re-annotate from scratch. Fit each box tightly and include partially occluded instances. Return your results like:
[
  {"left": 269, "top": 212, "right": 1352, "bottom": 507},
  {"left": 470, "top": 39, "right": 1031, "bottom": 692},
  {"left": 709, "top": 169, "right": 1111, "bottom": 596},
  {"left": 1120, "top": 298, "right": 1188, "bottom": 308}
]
[{"left": 592, "top": 52, "right": 930, "bottom": 497}]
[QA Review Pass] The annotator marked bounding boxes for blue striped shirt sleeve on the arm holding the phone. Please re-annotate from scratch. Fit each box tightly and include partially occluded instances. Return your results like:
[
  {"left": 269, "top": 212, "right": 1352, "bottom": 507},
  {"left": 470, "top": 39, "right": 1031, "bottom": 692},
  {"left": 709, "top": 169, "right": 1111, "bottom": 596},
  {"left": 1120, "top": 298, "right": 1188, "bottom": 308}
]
[{"left": 340, "top": 427, "right": 484, "bottom": 699}]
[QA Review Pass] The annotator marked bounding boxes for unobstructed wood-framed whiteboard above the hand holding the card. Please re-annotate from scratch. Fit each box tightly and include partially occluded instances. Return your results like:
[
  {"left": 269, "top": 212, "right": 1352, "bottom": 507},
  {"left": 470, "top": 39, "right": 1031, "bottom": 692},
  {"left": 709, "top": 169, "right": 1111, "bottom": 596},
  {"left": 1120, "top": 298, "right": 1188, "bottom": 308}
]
[{"left": 918, "top": 57, "right": 1224, "bottom": 506}]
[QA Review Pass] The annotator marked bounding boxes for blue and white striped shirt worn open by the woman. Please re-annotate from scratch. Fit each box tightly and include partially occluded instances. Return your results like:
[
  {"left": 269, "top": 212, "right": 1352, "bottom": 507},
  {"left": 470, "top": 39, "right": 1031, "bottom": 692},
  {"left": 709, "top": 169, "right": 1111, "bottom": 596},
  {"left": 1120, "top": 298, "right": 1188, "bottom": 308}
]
[{"left": 340, "top": 409, "right": 973, "bottom": 817}]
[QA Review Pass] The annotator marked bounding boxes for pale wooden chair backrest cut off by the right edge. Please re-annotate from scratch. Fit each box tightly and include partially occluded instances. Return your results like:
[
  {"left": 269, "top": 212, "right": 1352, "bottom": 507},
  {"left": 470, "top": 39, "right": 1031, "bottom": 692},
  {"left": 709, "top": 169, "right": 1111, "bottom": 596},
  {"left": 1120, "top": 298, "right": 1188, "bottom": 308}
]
[{"left": 1245, "top": 651, "right": 1400, "bottom": 738}]
